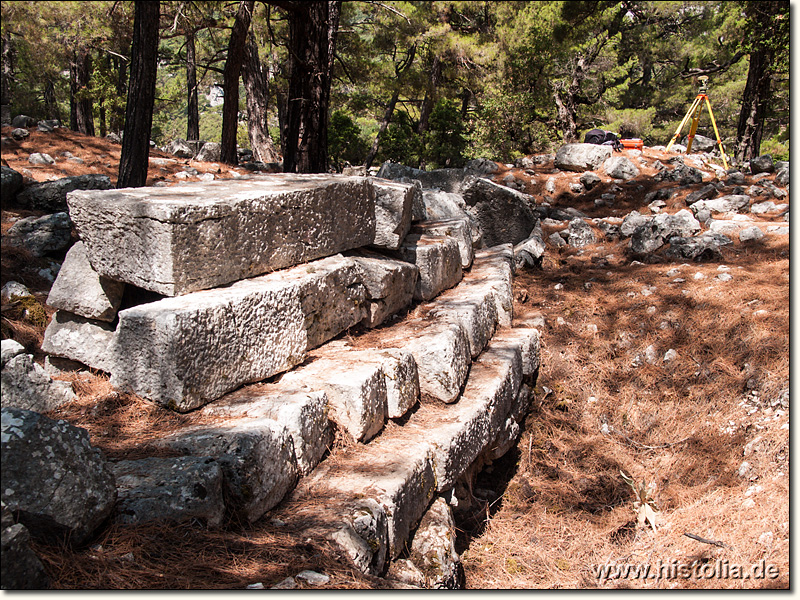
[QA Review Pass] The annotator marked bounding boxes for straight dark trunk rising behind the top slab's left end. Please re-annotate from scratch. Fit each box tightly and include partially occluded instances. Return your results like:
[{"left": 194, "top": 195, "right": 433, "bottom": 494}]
[{"left": 117, "top": 0, "right": 161, "bottom": 188}]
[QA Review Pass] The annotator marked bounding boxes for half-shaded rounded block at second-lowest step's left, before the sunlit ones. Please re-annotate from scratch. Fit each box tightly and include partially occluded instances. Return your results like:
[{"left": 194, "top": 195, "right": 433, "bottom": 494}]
[{"left": 158, "top": 418, "right": 297, "bottom": 523}]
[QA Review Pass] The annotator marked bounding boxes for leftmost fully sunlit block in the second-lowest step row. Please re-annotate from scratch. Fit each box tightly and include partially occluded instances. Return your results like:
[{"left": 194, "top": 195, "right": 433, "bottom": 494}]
[{"left": 201, "top": 381, "right": 333, "bottom": 475}]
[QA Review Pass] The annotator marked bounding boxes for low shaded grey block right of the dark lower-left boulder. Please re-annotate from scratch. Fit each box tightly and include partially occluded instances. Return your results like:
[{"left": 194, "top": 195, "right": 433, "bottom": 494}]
[{"left": 112, "top": 456, "right": 225, "bottom": 527}]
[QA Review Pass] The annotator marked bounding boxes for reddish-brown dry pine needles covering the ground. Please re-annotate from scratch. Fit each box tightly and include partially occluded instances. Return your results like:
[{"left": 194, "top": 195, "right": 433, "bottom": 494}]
[{"left": 2, "top": 130, "right": 789, "bottom": 589}]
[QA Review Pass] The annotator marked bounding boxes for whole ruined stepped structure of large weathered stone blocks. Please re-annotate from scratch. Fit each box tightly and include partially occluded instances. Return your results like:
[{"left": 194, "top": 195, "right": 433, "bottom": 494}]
[{"left": 43, "top": 175, "right": 539, "bottom": 575}]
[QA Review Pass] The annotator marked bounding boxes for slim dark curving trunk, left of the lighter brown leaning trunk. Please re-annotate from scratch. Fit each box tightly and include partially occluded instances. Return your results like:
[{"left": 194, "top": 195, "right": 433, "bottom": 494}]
[{"left": 220, "top": 0, "right": 255, "bottom": 165}]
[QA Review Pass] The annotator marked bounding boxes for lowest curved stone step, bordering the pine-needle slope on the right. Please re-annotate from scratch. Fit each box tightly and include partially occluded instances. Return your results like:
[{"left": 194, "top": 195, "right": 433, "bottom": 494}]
[{"left": 275, "top": 329, "right": 539, "bottom": 575}]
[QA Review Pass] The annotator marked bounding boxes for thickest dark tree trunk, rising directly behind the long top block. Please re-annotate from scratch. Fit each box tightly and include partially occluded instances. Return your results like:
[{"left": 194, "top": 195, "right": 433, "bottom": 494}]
[{"left": 269, "top": 0, "right": 341, "bottom": 173}]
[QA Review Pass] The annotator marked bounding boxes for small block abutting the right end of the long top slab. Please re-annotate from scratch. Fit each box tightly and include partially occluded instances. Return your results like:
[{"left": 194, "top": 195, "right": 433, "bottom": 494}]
[{"left": 370, "top": 178, "right": 422, "bottom": 250}]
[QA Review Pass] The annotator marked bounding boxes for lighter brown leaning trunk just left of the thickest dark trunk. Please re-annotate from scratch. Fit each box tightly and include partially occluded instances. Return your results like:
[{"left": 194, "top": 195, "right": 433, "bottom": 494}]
[{"left": 242, "top": 31, "right": 278, "bottom": 163}]
